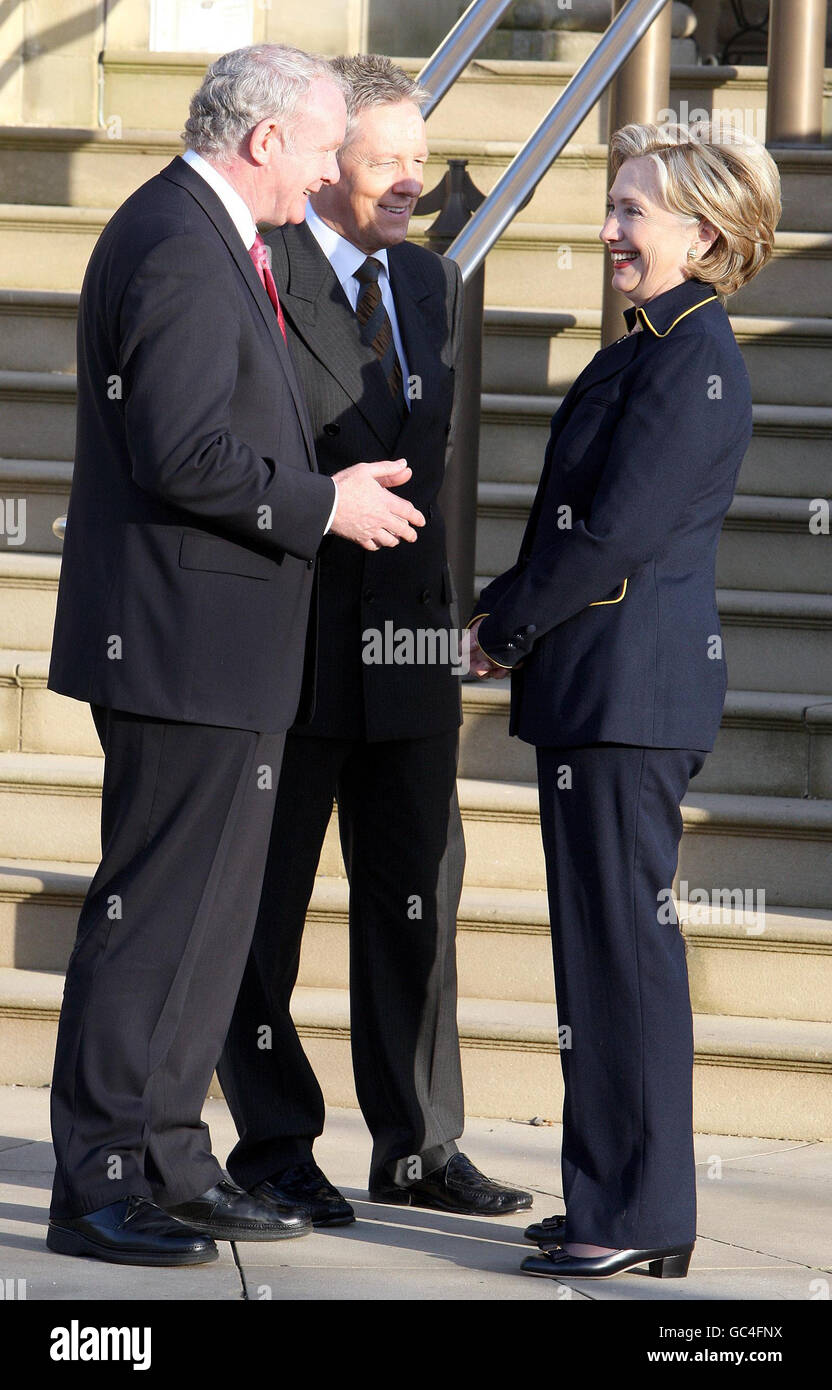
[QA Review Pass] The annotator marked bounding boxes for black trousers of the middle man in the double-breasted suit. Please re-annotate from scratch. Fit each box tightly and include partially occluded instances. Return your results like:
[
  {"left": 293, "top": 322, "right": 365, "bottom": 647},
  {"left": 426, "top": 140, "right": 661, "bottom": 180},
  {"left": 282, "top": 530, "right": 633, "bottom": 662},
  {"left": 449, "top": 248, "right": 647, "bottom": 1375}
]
[{"left": 219, "top": 730, "right": 465, "bottom": 1187}]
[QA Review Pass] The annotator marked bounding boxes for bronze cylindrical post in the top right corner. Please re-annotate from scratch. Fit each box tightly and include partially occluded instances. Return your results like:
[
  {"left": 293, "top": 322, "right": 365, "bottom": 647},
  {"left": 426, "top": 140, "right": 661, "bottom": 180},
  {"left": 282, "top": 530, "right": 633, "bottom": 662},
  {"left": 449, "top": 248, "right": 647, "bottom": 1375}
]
[{"left": 765, "top": 0, "right": 826, "bottom": 145}]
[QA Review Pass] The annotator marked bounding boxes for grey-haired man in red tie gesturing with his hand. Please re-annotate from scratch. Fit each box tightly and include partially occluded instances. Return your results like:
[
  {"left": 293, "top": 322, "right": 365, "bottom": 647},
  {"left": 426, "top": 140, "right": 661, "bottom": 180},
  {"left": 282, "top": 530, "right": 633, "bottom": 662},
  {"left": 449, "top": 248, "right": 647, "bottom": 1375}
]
[{"left": 47, "top": 46, "right": 422, "bottom": 1264}]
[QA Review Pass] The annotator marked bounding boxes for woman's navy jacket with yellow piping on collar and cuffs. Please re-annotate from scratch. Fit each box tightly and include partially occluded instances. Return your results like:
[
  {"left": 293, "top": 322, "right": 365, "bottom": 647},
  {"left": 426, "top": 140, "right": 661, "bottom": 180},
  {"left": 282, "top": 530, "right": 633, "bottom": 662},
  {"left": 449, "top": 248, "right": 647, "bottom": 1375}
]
[{"left": 476, "top": 281, "right": 751, "bottom": 749}]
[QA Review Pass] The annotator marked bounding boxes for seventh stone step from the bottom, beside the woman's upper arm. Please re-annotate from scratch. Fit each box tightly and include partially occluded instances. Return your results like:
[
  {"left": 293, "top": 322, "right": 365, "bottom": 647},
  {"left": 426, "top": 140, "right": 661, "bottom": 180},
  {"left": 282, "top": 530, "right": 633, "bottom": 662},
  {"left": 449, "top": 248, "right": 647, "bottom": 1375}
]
[{"left": 479, "top": 392, "right": 832, "bottom": 498}]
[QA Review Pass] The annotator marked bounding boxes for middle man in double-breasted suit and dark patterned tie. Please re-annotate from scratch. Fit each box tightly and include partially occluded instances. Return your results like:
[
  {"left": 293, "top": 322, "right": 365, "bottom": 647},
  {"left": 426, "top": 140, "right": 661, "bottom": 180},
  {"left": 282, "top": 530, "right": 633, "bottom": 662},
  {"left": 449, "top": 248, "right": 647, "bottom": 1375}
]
[{"left": 219, "top": 56, "right": 531, "bottom": 1226}]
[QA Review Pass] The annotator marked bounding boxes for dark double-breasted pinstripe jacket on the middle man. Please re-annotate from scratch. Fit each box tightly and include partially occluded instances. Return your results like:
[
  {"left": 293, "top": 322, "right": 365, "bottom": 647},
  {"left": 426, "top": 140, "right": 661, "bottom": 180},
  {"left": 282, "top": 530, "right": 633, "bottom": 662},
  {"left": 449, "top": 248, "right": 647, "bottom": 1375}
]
[{"left": 267, "top": 224, "right": 463, "bottom": 741}]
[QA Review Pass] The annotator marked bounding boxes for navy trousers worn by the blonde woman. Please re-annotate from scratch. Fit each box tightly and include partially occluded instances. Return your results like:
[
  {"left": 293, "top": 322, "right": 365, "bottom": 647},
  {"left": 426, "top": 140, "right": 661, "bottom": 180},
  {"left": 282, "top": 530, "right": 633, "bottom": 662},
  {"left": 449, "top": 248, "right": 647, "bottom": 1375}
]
[{"left": 538, "top": 744, "right": 706, "bottom": 1250}]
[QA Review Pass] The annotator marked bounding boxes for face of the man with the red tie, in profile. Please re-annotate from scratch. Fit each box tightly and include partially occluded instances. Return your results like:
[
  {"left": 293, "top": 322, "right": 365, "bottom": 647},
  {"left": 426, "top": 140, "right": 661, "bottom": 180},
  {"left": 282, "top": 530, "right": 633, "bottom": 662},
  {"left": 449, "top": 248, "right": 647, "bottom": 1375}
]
[{"left": 251, "top": 78, "right": 347, "bottom": 227}]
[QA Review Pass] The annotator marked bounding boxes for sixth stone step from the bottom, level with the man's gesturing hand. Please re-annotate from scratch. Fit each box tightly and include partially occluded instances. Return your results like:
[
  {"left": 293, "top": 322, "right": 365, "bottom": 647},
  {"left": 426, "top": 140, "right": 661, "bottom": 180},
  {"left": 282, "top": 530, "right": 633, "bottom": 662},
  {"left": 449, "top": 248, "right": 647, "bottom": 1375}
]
[{"left": 476, "top": 482, "right": 832, "bottom": 594}]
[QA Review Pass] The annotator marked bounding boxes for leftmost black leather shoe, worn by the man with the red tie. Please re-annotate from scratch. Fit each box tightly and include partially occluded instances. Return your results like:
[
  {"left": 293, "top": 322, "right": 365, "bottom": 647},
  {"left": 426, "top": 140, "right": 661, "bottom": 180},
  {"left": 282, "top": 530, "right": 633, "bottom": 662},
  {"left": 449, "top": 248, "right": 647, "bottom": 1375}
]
[{"left": 46, "top": 1197, "right": 217, "bottom": 1265}]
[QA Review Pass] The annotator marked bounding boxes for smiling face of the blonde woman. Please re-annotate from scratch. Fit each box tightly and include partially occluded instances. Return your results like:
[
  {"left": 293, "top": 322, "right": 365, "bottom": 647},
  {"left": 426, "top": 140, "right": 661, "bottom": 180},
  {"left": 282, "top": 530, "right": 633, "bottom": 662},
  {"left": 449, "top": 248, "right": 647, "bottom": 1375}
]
[{"left": 599, "top": 157, "right": 713, "bottom": 304}]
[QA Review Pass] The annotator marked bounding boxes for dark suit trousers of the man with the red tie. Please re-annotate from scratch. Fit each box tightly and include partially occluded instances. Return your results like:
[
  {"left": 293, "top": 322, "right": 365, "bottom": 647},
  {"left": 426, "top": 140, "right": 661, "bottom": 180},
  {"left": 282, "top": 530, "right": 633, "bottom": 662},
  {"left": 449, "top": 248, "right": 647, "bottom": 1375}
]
[{"left": 51, "top": 706, "right": 285, "bottom": 1218}]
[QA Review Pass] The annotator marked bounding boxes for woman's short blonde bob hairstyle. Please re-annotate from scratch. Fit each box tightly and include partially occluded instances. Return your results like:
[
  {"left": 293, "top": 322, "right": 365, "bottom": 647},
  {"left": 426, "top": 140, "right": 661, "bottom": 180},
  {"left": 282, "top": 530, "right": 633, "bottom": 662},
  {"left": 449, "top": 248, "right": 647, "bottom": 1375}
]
[{"left": 610, "top": 121, "right": 781, "bottom": 299}]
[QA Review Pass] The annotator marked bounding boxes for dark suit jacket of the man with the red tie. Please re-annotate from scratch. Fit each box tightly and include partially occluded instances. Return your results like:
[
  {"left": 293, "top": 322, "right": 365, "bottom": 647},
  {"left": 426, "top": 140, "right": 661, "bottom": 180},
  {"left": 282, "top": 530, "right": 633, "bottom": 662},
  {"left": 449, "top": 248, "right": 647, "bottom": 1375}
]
[{"left": 49, "top": 158, "right": 333, "bottom": 733}]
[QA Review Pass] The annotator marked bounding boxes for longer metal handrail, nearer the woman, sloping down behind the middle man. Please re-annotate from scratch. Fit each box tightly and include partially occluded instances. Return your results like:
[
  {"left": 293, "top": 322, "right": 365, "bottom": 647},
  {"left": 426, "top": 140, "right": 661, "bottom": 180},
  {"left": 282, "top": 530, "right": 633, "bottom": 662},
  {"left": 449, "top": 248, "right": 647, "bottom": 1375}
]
[{"left": 444, "top": 0, "right": 668, "bottom": 281}]
